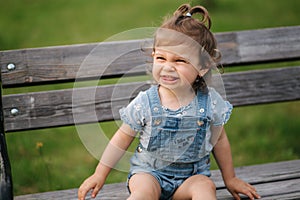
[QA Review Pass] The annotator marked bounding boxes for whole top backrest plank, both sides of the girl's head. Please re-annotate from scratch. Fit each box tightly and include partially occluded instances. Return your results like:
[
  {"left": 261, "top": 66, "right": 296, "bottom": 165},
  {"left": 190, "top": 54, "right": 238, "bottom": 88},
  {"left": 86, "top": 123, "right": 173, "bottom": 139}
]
[{"left": 0, "top": 26, "right": 300, "bottom": 87}]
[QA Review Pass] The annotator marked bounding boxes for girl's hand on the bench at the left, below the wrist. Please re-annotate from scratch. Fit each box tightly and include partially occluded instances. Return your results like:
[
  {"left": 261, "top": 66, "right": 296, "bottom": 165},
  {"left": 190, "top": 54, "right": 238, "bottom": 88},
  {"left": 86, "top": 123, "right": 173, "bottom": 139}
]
[{"left": 78, "top": 173, "right": 104, "bottom": 200}]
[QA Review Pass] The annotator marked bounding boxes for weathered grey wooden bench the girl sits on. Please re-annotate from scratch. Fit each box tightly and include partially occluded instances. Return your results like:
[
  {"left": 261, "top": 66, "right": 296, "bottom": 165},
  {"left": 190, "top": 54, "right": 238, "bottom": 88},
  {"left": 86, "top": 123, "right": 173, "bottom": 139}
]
[{"left": 0, "top": 26, "right": 300, "bottom": 200}]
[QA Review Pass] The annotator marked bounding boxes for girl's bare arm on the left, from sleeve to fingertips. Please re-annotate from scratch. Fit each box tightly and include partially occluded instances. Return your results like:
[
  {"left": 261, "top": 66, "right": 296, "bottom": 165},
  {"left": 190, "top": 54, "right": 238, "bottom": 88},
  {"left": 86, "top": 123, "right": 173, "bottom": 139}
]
[{"left": 78, "top": 124, "right": 136, "bottom": 200}]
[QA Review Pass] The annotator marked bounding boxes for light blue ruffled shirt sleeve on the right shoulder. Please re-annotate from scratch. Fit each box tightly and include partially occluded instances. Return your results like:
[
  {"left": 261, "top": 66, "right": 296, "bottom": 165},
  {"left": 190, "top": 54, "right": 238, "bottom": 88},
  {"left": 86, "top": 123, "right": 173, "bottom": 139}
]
[{"left": 210, "top": 89, "right": 233, "bottom": 126}]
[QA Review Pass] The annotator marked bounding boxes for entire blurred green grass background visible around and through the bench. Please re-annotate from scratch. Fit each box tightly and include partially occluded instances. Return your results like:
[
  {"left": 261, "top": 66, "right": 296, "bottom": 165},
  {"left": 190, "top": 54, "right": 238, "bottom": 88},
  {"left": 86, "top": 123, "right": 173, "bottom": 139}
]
[{"left": 0, "top": 0, "right": 300, "bottom": 195}]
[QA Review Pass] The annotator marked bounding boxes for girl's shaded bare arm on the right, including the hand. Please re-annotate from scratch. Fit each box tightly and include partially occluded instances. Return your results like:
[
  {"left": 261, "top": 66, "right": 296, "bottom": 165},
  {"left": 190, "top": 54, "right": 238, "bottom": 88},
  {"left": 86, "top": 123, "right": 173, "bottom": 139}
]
[{"left": 213, "top": 128, "right": 260, "bottom": 200}]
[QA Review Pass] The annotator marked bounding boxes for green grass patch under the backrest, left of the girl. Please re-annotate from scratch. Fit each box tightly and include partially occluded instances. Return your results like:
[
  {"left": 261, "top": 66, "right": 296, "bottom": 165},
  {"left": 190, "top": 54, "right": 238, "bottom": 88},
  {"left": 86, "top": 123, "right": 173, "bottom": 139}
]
[{"left": 7, "top": 127, "right": 95, "bottom": 194}]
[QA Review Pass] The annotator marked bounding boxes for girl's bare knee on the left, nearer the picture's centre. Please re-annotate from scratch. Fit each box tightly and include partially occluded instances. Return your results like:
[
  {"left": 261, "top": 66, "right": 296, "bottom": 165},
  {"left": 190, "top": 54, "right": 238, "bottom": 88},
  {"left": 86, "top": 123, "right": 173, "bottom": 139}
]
[{"left": 128, "top": 173, "right": 161, "bottom": 200}]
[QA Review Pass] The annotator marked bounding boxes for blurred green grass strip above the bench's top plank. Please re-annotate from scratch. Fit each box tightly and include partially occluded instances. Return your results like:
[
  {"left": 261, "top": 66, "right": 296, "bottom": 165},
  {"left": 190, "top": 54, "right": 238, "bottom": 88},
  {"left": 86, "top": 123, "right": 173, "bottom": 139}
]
[{"left": 0, "top": 0, "right": 300, "bottom": 49}]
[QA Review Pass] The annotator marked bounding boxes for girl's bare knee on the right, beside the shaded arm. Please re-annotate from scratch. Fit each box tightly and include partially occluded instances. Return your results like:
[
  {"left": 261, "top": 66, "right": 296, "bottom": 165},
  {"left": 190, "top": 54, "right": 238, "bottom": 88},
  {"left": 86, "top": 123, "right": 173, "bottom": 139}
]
[{"left": 173, "top": 175, "right": 217, "bottom": 200}]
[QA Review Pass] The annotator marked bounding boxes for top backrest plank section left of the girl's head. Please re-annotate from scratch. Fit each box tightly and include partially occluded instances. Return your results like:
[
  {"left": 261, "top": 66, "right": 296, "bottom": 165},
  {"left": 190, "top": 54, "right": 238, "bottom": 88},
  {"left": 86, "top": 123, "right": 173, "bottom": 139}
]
[{"left": 0, "top": 41, "right": 148, "bottom": 87}]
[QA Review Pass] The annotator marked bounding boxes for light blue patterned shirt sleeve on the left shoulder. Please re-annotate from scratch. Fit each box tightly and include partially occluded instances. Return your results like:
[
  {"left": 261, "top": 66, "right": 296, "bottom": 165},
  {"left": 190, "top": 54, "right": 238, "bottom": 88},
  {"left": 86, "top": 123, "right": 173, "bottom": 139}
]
[{"left": 119, "top": 92, "right": 149, "bottom": 132}]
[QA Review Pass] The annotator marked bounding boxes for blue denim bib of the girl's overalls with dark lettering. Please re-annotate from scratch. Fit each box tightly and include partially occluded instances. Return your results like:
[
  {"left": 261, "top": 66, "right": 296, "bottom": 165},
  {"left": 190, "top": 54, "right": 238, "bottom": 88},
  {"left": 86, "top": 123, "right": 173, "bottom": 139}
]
[{"left": 147, "top": 116, "right": 207, "bottom": 162}]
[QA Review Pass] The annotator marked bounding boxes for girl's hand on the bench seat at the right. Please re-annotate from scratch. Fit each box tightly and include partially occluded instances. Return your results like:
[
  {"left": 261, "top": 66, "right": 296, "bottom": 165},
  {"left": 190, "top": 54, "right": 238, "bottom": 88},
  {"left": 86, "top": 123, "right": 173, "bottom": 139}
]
[{"left": 226, "top": 177, "right": 260, "bottom": 200}]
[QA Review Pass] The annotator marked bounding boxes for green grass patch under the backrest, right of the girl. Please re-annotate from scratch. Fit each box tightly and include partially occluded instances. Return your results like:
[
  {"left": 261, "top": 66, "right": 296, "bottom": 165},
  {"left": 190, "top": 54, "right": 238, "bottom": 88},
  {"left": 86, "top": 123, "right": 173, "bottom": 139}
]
[{"left": 227, "top": 102, "right": 300, "bottom": 166}]
